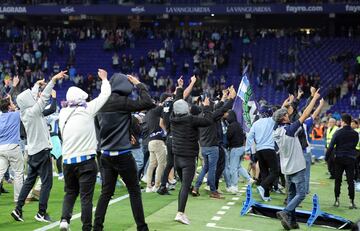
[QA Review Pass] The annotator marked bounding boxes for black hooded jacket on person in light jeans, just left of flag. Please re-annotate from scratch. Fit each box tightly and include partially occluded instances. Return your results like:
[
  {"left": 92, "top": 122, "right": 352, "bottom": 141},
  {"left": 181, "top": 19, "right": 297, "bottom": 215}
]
[{"left": 226, "top": 110, "right": 246, "bottom": 148}]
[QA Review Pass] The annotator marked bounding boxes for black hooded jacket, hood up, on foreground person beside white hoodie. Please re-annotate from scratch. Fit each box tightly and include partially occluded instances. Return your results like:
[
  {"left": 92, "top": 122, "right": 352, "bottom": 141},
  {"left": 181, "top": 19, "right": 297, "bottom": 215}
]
[{"left": 95, "top": 76, "right": 155, "bottom": 151}]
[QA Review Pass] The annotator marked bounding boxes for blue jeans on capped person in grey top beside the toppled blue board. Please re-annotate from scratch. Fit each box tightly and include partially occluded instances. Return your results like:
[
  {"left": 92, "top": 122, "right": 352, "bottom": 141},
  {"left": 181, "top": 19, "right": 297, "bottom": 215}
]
[{"left": 284, "top": 169, "right": 306, "bottom": 222}]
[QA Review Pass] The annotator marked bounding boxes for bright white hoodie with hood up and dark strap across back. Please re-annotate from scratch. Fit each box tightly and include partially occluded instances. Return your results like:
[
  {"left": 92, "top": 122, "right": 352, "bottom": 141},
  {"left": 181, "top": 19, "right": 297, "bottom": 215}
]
[{"left": 59, "top": 80, "right": 111, "bottom": 163}]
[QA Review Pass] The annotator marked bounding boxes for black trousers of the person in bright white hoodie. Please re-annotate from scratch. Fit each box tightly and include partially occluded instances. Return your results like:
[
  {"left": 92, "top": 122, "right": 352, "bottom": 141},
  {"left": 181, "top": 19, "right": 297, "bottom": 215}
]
[{"left": 61, "top": 158, "right": 97, "bottom": 230}]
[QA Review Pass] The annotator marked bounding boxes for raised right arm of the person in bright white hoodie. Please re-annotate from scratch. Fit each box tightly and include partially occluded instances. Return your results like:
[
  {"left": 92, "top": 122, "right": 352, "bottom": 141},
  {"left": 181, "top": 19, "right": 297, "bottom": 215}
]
[{"left": 86, "top": 69, "right": 111, "bottom": 116}]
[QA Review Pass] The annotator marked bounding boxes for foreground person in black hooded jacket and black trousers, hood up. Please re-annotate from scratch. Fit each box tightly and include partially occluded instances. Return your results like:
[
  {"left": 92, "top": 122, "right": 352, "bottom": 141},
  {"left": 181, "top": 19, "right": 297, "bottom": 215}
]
[{"left": 94, "top": 74, "right": 155, "bottom": 231}]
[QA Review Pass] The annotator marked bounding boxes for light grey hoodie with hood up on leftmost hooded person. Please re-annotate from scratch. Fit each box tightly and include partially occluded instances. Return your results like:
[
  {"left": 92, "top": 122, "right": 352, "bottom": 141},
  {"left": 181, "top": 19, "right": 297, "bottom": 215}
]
[{"left": 17, "top": 81, "right": 54, "bottom": 155}]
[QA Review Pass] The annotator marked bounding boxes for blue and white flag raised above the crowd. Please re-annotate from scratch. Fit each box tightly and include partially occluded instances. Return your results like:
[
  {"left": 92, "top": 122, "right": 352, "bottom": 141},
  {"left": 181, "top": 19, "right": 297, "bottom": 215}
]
[{"left": 233, "top": 67, "right": 258, "bottom": 132}]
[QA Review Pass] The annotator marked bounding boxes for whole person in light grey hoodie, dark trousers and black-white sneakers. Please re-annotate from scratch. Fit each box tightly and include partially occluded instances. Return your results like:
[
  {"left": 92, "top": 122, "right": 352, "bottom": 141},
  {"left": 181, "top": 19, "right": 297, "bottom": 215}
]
[{"left": 11, "top": 71, "right": 66, "bottom": 222}]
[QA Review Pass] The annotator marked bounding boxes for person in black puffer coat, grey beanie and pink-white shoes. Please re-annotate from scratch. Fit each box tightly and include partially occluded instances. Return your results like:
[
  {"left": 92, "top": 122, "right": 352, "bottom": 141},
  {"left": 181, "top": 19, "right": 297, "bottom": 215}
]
[{"left": 170, "top": 88, "right": 212, "bottom": 225}]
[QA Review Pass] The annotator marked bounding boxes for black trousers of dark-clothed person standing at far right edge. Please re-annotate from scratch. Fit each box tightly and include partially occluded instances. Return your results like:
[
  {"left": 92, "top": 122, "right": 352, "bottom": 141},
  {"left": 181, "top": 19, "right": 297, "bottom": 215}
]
[{"left": 334, "top": 157, "right": 355, "bottom": 200}]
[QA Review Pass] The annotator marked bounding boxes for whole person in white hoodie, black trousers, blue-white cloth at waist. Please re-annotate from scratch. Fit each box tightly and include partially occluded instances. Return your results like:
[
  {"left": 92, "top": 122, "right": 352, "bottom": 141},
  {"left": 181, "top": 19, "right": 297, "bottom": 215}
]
[{"left": 59, "top": 69, "right": 111, "bottom": 230}]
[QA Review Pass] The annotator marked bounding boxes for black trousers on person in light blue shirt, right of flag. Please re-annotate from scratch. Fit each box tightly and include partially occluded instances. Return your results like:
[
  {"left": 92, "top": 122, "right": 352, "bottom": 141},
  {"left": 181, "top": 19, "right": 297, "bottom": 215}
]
[{"left": 256, "top": 149, "right": 279, "bottom": 197}]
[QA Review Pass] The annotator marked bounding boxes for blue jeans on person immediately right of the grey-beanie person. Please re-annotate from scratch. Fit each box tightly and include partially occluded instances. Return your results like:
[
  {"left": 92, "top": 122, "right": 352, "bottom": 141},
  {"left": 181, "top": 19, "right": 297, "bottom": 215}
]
[{"left": 195, "top": 146, "right": 219, "bottom": 192}]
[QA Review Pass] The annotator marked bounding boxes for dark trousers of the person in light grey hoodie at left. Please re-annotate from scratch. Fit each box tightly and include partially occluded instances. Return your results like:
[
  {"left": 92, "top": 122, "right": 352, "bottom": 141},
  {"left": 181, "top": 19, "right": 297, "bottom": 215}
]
[{"left": 16, "top": 149, "right": 53, "bottom": 214}]
